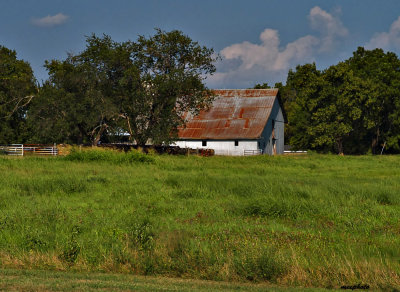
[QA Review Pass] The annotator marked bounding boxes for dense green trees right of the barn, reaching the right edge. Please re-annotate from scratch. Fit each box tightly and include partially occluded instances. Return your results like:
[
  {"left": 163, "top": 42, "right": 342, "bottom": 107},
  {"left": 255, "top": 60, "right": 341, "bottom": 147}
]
[{"left": 276, "top": 47, "right": 400, "bottom": 154}]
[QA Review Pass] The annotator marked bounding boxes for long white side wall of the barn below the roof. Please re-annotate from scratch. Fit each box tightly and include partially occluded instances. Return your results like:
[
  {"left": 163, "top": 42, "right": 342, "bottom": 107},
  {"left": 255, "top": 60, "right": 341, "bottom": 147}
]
[{"left": 175, "top": 139, "right": 258, "bottom": 156}]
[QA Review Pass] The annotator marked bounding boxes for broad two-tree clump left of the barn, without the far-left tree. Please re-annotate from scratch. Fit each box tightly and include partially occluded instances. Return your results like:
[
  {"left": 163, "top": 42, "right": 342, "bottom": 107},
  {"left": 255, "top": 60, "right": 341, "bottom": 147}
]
[{"left": 31, "top": 29, "right": 215, "bottom": 145}]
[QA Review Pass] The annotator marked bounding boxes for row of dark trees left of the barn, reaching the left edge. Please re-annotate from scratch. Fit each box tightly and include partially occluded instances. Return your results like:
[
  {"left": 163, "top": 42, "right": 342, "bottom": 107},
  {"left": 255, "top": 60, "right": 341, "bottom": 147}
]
[{"left": 0, "top": 29, "right": 215, "bottom": 145}]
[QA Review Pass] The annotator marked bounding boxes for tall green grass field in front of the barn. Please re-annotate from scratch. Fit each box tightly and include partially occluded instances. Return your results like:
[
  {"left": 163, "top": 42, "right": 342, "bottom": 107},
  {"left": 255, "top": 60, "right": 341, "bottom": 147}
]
[{"left": 0, "top": 153, "right": 400, "bottom": 289}]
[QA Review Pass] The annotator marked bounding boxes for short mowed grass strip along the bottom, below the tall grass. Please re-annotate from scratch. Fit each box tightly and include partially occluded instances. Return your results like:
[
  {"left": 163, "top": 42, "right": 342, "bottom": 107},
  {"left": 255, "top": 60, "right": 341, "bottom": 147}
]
[{"left": 0, "top": 270, "right": 327, "bottom": 292}]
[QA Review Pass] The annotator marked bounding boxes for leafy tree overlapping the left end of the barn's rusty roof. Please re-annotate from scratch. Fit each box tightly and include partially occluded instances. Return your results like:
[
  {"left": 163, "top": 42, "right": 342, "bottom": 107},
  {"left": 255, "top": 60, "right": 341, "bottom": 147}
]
[{"left": 123, "top": 29, "right": 215, "bottom": 145}]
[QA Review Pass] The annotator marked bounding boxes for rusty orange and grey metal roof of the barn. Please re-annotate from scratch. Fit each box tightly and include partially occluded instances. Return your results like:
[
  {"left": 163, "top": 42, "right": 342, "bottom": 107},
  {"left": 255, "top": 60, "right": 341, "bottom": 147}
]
[{"left": 178, "top": 89, "right": 278, "bottom": 140}]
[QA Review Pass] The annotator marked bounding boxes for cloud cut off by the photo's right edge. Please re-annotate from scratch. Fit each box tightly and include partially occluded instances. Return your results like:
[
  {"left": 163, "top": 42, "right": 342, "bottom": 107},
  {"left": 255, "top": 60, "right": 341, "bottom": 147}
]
[{"left": 366, "top": 16, "right": 400, "bottom": 49}]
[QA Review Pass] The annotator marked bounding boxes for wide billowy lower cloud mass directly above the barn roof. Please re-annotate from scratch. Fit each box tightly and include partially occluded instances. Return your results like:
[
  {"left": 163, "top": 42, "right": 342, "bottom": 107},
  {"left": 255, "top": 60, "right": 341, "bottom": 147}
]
[{"left": 209, "top": 28, "right": 319, "bottom": 87}]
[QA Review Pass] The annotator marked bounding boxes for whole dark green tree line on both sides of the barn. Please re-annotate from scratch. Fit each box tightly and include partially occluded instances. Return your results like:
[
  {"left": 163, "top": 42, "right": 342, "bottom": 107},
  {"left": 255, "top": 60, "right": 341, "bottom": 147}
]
[{"left": 0, "top": 30, "right": 400, "bottom": 154}]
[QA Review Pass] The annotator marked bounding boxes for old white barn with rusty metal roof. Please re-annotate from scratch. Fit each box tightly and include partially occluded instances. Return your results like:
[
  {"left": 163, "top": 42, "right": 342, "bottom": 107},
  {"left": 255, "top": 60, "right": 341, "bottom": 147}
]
[{"left": 175, "top": 89, "right": 286, "bottom": 156}]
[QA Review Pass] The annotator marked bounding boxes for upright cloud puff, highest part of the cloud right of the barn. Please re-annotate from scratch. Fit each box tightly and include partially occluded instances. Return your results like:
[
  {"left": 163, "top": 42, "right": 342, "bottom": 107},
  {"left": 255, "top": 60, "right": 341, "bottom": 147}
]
[{"left": 308, "top": 6, "right": 349, "bottom": 52}]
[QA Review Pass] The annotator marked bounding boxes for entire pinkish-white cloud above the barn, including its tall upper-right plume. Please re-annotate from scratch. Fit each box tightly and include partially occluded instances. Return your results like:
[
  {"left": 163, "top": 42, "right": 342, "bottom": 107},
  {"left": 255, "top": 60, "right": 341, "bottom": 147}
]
[{"left": 207, "top": 6, "right": 348, "bottom": 88}]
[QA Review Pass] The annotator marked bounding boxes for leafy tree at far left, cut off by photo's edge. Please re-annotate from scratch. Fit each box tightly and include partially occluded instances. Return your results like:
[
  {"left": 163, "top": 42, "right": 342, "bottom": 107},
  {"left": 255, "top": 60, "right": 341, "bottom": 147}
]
[{"left": 0, "top": 46, "right": 36, "bottom": 144}]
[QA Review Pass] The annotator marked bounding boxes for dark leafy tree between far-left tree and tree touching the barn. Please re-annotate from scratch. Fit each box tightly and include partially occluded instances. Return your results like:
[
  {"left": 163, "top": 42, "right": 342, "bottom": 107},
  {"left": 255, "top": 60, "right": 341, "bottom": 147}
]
[{"left": 29, "top": 35, "right": 127, "bottom": 145}]
